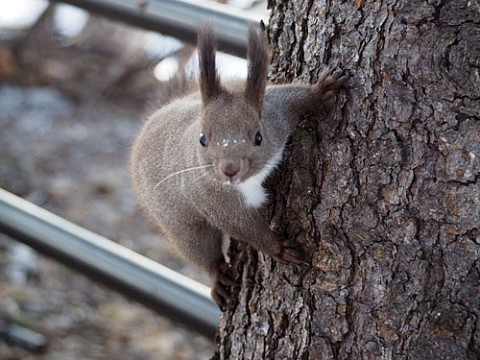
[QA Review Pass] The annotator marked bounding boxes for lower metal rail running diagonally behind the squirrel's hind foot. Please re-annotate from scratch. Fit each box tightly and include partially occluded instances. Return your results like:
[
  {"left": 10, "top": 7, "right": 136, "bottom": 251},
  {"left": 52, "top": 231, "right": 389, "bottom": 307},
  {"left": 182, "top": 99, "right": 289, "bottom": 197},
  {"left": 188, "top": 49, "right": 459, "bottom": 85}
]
[{"left": 0, "top": 189, "right": 220, "bottom": 338}]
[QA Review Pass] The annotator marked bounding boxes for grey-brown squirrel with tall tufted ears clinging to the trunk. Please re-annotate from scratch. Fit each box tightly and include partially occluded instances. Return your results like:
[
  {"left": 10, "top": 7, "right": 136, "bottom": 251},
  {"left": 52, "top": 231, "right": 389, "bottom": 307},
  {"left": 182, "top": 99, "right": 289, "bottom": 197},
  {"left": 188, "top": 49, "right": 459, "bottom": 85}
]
[{"left": 131, "top": 25, "right": 346, "bottom": 310}]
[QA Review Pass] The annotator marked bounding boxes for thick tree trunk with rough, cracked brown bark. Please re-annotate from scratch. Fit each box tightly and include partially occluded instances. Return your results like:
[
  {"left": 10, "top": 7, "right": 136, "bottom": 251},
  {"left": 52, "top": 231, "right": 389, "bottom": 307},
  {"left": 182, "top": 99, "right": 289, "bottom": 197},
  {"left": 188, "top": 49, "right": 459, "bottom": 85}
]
[{"left": 215, "top": 0, "right": 480, "bottom": 360}]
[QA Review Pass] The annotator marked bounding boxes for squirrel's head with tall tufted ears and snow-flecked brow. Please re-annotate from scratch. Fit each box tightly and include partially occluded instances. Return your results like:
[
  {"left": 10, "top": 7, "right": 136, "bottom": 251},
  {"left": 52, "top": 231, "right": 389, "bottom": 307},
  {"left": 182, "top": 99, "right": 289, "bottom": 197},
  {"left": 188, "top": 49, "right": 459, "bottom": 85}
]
[{"left": 197, "top": 26, "right": 274, "bottom": 184}]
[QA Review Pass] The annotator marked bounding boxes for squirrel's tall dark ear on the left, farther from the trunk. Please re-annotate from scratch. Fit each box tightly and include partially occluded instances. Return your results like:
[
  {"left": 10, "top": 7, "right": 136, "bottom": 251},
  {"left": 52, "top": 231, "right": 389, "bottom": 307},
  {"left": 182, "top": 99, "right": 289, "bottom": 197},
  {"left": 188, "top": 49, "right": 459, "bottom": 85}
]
[{"left": 198, "top": 24, "right": 221, "bottom": 105}]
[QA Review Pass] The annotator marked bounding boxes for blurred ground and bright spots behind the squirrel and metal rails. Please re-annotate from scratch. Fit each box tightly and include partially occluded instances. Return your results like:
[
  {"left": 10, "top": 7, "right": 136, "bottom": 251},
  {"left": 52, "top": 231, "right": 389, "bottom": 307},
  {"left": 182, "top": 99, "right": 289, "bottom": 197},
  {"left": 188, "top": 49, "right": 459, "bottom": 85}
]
[{"left": 0, "top": 0, "right": 267, "bottom": 360}]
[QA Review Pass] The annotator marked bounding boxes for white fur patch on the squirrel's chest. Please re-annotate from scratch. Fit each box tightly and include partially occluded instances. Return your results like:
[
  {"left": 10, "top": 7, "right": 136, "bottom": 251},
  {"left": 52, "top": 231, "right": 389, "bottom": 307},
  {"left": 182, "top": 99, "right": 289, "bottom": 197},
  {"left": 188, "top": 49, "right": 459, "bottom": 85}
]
[{"left": 238, "top": 149, "right": 283, "bottom": 208}]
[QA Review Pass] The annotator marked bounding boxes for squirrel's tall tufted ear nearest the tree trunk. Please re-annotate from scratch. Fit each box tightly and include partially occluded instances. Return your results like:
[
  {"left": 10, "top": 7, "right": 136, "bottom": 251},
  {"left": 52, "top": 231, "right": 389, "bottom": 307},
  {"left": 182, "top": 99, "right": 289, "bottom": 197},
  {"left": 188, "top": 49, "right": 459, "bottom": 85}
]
[{"left": 245, "top": 24, "right": 269, "bottom": 111}]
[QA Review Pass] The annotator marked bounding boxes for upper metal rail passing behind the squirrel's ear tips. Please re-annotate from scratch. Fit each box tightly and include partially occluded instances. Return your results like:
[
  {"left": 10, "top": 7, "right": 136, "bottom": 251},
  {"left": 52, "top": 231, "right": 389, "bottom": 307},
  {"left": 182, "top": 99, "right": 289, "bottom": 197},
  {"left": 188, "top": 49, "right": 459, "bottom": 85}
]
[{"left": 51, "top": 0, "right": 261, "bottom": 57}]
